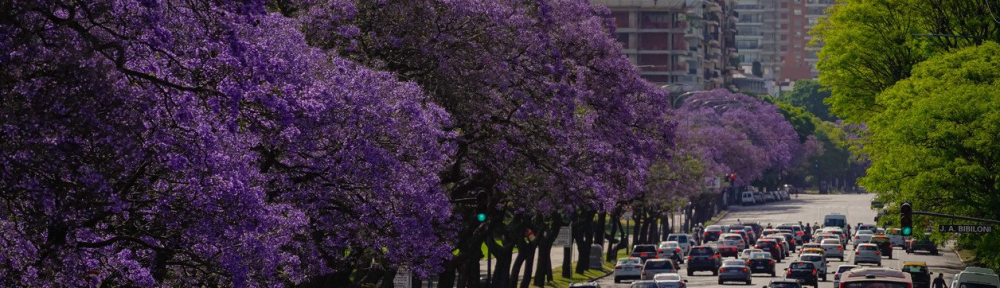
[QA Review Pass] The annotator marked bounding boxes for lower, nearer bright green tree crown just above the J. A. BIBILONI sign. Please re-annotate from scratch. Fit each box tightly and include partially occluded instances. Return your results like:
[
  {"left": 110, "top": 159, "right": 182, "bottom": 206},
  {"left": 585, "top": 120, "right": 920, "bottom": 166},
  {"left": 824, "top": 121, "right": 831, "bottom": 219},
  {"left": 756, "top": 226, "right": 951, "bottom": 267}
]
[{"left": 862, "top": 42, "right": 1000, "bottom": 267}]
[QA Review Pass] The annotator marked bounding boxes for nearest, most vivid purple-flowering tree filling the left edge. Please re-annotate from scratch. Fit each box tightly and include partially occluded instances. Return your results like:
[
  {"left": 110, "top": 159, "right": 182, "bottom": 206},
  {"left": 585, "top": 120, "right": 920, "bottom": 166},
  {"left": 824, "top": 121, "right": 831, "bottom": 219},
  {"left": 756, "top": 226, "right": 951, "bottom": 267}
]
[{"left": 0, "top": 0, "right": 452, "bottom": 287}]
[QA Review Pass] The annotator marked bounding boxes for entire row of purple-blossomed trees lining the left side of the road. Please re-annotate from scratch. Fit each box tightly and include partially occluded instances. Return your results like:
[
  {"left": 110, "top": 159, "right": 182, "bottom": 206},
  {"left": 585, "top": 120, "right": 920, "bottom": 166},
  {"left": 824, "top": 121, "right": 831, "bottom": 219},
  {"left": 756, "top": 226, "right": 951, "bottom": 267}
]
[{"left": 0, "top": 0, "right": 817, "bottom": 287}]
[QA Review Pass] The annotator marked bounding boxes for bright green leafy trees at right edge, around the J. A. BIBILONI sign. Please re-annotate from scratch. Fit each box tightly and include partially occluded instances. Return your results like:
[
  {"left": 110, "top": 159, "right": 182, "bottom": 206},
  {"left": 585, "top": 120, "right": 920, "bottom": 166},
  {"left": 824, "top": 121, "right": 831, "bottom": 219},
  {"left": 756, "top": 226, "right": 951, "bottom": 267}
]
[{"left": 812, "top": 0, "right": 1000, "bottom": 268}]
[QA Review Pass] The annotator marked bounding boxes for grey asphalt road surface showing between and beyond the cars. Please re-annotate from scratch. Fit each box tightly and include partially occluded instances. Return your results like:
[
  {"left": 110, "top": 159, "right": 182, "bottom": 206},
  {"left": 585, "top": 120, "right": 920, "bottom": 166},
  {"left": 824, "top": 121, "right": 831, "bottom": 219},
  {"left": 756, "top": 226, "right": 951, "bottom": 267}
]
[{"left": 598, "top": 194, "right": 964, "bottom": 288}]
